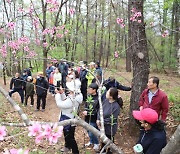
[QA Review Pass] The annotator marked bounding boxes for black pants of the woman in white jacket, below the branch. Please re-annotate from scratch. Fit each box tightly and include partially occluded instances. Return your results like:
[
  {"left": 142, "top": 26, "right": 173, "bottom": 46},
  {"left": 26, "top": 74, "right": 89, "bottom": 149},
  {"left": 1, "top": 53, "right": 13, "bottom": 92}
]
[{"left": 63, "top": 126, "right": 79, "bottom": 154}]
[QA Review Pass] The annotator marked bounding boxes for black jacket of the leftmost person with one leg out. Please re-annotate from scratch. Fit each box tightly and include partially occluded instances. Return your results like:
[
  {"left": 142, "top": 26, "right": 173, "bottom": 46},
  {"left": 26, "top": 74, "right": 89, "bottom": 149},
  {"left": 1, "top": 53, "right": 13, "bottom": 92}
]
[{"left": 10, "top": 77, "right": 24, "bottom": 90}]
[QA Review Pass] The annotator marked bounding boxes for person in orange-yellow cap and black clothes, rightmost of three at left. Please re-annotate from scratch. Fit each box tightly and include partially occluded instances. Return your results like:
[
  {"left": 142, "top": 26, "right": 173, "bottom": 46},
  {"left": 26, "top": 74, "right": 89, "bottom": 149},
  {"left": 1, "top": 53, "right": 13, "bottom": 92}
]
[{"left": 35, "top": 72, "right": 49, "bottom": 112}]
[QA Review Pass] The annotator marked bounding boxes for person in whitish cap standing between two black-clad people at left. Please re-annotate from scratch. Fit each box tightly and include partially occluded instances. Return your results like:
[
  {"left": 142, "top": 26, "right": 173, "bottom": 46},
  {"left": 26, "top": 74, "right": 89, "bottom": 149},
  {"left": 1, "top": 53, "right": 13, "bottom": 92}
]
[{"left": 25, "top": 76, "right": 35, "bottom": 106}]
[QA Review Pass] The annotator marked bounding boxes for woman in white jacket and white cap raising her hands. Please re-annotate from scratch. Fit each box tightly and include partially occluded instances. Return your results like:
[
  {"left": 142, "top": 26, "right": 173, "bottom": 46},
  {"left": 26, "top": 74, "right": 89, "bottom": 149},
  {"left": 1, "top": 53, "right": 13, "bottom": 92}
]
[{"left": 55, "top": 81, "right": 83, "bottom": 154}]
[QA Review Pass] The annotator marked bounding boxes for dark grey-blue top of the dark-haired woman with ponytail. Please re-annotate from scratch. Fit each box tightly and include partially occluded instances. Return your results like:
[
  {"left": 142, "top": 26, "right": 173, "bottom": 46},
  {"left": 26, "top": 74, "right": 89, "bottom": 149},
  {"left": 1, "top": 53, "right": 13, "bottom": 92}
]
[{"left": 97, "top": 99, "right": 120, "bottom": 136}]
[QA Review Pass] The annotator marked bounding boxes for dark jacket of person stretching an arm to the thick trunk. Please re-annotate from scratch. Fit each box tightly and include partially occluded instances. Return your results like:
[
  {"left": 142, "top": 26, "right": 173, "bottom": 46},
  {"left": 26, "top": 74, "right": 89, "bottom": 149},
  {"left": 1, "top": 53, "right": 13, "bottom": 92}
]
[{"left": 103, "top": 79, "right": 131, "bottom": 91}]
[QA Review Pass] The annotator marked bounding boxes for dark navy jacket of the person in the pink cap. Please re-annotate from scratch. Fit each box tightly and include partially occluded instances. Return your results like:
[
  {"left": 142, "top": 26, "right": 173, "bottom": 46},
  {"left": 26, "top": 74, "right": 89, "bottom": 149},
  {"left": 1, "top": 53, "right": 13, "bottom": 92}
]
[{"left": 138, "top": 128, "right": 166, "bottom": 154}]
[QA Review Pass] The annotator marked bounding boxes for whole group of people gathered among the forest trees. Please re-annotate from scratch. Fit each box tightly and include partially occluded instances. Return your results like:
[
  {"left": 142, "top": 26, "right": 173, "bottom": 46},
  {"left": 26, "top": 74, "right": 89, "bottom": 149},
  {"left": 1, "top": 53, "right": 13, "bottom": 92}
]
[{"left": 9, "top": 61, "right": 169, "bottom": 154}]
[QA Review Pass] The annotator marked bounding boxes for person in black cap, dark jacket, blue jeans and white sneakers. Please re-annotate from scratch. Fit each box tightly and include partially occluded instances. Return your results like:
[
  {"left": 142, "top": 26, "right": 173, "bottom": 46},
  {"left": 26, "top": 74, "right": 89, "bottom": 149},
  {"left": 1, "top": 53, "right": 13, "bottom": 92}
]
[{"left": 83, "top": 83, "right": 99, "bottom": 151}]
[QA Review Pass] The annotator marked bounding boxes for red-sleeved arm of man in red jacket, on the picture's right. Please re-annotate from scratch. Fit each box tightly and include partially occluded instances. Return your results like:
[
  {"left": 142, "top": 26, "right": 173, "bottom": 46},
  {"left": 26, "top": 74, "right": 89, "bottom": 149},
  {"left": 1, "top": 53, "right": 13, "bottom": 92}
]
[{"left": 161, "top": 96, "right": 169, "bottom": 121}]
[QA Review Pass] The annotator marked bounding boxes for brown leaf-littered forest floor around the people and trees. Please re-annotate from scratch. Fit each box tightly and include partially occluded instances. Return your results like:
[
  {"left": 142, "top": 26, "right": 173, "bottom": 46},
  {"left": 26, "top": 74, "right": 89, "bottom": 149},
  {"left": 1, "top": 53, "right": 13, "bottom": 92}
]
[{"left": 0, "top": 71, "right": 180, "bottom": 154}]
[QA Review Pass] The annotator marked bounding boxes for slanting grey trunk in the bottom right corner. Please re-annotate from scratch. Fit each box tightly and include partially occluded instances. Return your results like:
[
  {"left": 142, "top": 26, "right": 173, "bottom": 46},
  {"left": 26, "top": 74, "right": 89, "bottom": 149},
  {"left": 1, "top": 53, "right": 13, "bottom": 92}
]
[{"left": 161, "top": 125, "right": 180, "bottom": 154}]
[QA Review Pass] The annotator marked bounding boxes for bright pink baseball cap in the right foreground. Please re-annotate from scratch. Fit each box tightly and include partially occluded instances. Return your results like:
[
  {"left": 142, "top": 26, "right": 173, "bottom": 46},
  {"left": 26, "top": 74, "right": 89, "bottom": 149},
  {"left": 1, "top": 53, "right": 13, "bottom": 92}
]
[{"left": 133, "top": 108, "right": 158, "bottom": 124}]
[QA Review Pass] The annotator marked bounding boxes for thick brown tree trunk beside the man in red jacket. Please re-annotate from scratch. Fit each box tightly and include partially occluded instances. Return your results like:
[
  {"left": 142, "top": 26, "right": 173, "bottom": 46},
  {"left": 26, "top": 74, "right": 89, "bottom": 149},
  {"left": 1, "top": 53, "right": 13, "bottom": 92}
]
[{"left": 129, "top": 0, "right": 149, "bottom": 130}]
